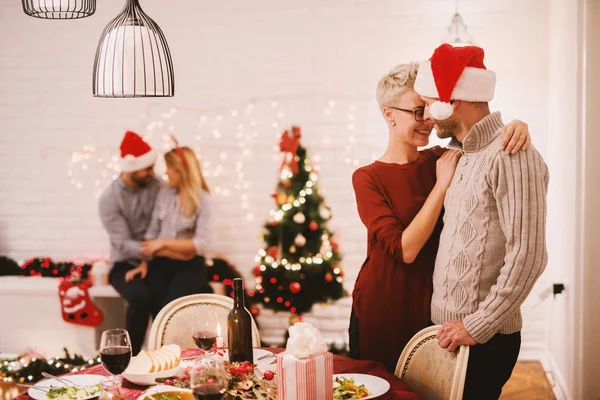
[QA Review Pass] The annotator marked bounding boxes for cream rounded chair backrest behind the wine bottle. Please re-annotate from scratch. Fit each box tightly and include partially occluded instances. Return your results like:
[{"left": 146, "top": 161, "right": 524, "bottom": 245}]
[{"left": 148, "top": 294, "right": 260, "bottom": 350}]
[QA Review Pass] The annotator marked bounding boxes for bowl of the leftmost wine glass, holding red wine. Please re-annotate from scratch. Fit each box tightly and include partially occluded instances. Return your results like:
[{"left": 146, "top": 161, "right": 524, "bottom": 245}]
[{"left": 100, "top": 329, "right": 131, "bottom": 380}]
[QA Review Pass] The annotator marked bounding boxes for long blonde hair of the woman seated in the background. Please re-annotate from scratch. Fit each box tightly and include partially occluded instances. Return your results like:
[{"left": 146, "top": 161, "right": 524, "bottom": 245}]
[{"left": 165, "top": 146, "right": 210, "bottom": 217}]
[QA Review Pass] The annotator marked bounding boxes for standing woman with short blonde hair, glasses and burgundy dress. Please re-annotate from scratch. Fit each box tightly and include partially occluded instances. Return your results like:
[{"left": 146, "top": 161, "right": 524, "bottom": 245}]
[{"left": 349, "top": 63, "right": 530, "bottom": 372}]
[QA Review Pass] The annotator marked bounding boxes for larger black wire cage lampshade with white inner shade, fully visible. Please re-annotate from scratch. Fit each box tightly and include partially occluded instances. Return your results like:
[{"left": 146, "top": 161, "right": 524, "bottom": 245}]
[{"left": 92, "top": 0, "right": 175, "bottom": 98}]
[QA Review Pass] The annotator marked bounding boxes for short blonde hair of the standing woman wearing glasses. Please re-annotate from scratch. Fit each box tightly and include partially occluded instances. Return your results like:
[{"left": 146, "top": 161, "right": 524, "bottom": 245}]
[{"left": 377, "top": 62, "right": 419, "bottom": 110}]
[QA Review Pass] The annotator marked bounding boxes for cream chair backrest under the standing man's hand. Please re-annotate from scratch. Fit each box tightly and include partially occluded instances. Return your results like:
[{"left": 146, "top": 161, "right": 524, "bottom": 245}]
[{"left": 395, "top": 325, "right": 469, "bottom": 400}]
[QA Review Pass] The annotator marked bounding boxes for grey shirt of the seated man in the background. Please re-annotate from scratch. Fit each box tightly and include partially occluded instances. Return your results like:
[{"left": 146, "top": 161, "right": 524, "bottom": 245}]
[{"left": 99, "top": 177, "right": 164, "bottom": 265}]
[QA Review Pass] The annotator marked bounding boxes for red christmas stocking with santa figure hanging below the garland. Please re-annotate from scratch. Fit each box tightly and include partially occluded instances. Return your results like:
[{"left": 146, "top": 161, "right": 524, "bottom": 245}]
[{"left": 58, "top": 279, "right": 104, "bottom": 326}]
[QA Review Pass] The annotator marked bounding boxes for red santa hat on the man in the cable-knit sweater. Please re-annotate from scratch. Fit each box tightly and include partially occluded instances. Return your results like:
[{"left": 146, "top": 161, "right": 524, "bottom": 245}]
[{"left": 415, "top": 43, "right": 496, "bottom": 120}]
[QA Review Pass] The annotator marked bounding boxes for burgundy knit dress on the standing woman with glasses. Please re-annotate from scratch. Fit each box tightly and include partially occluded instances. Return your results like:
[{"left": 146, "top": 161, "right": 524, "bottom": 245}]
[{"left": 352, "top": 147, "right": 444, "bottom": 372}]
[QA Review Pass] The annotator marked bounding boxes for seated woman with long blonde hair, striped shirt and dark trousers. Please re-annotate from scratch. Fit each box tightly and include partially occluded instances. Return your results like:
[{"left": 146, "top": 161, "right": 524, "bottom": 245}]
[{"left": 126, "top": 142, "right": 212, "bottom": 314}]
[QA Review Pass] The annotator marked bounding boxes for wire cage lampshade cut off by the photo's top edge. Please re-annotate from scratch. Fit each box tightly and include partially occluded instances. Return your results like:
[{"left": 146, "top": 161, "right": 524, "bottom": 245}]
[{"left": 22, "top": 0, "right": 96, "bottom": 19}]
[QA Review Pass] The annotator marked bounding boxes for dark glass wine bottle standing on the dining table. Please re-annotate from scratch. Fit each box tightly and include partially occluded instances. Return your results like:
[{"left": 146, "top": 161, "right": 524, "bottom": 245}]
[{"left": 227, "top": 278, "right": 254, "bottom": 363}]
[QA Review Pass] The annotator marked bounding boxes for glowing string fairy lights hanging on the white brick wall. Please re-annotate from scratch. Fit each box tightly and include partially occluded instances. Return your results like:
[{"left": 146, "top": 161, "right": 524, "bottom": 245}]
[{"left": 67, "top": 92, "right": 372, "bottom": 220}]
